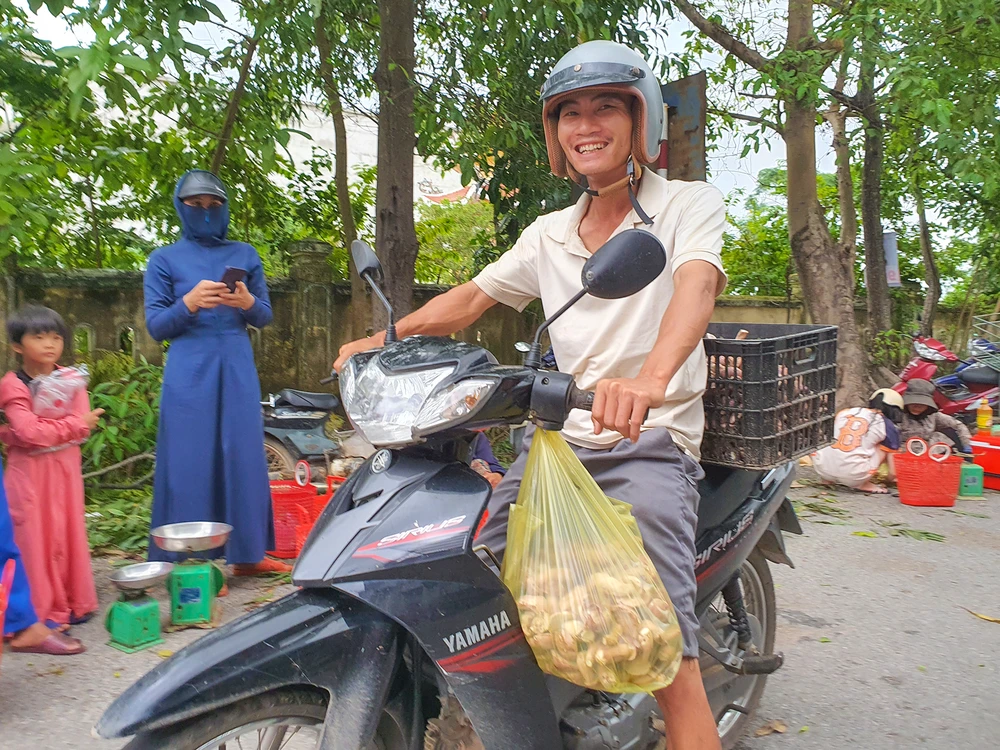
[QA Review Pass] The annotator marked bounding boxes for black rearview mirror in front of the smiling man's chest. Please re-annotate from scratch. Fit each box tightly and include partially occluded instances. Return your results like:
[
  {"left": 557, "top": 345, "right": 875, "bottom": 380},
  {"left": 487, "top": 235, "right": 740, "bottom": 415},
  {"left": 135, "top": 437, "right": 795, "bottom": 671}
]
[{"left": 580, "top": 229, "right": 667, "bottom": 299}]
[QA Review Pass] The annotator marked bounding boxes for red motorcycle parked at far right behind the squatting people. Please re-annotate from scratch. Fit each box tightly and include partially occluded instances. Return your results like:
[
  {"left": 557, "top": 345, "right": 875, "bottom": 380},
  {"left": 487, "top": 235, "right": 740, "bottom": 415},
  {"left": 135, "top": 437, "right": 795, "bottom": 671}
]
[{"left": 893, "top": 336, "right": 1000, "bottom": 424}]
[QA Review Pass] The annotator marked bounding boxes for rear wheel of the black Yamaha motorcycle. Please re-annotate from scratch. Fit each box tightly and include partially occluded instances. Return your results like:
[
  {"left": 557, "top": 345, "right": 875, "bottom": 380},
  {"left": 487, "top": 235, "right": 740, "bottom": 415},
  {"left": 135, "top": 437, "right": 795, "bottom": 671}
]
[{"left": 701, "top": 550, "right": 776, "bottom": 750}]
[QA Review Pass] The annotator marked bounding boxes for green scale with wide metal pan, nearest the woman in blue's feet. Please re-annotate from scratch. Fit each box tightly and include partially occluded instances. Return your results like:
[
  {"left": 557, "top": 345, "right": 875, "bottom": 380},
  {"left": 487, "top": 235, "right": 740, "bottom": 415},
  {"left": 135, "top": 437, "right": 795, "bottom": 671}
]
[{"left": 150, "top": 521, "right": 233, "bottom": 630}]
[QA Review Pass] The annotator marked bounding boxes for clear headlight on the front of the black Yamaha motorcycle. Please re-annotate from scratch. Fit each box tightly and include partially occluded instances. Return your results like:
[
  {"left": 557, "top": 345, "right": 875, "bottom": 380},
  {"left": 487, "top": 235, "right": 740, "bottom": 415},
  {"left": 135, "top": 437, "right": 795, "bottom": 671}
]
[{"left": 340, "top": 356, "right": 454, "bottom": 446}]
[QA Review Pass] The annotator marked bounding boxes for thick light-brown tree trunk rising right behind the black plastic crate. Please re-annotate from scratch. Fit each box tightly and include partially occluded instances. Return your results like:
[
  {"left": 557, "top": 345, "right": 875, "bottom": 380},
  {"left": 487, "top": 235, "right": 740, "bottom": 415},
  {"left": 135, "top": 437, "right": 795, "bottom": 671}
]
[{"left": 783, "top": 0, "right": 870, "bottom": 405}]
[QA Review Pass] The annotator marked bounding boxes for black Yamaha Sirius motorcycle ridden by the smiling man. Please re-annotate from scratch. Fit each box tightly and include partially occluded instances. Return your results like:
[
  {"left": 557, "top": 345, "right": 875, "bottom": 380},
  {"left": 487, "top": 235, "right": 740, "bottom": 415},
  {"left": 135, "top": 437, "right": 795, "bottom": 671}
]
[{"left": 95, "top": 230, "right": 802, "bottom": 750}]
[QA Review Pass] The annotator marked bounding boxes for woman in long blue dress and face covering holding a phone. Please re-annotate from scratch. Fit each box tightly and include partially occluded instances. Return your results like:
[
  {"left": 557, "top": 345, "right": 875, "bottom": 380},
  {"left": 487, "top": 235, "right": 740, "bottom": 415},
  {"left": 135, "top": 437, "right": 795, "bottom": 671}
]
[{"left": 144, "top": 170, "right": 291, "bottom": 575}]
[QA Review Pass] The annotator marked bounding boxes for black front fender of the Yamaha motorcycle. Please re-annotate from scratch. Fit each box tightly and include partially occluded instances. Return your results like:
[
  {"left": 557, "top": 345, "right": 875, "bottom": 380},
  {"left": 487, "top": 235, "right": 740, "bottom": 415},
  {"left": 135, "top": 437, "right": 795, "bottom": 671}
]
[{"left": 94, "top": 589, "right": 398, "bottom": 747}]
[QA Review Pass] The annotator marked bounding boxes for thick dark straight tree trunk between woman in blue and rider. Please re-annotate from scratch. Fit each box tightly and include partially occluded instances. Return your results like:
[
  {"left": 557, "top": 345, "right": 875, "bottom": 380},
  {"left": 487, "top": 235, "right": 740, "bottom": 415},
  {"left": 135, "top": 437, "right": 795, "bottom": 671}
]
[{"left": 373, "top": 0, "right": 417, "bottom": 327}]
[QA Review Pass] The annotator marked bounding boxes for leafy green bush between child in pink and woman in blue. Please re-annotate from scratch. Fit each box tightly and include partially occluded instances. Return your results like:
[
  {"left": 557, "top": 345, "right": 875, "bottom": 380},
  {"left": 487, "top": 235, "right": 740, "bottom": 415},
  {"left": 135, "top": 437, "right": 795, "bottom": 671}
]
[{"left": 83, "top": 355, "right": 163, "bottom": 485}]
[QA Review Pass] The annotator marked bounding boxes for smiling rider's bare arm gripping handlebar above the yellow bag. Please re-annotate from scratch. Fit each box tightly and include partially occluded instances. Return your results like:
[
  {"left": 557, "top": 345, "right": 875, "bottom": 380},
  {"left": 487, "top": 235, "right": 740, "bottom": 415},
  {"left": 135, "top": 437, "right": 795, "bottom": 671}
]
[{"left": 592, "top": 260, "right": 719, "bottom": 442}]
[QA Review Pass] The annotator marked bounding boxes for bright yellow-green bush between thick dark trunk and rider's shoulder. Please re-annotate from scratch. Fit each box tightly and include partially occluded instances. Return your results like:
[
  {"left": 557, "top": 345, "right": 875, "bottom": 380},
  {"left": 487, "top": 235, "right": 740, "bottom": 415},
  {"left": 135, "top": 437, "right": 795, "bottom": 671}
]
[{"left": 416, "top": 201, "right": 494, "bottom": 284}]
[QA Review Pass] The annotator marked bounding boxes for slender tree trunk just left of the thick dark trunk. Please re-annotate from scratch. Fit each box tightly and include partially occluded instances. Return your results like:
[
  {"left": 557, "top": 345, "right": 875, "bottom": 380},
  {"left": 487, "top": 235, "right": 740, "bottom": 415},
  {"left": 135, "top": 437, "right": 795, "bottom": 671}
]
[{"left": 316, "top": 13, "right": 368, "bottom": 339}]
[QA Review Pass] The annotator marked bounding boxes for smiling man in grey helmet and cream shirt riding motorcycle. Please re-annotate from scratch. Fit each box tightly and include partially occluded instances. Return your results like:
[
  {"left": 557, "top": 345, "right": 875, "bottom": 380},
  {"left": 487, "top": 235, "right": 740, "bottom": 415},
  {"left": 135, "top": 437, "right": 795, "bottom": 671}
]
[{"left": 334, "top": 41, "right": 726, "bottom": 750}]
